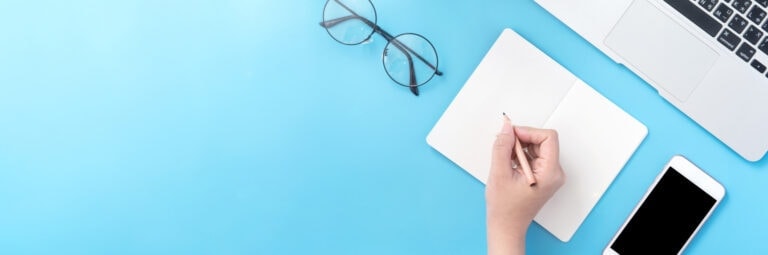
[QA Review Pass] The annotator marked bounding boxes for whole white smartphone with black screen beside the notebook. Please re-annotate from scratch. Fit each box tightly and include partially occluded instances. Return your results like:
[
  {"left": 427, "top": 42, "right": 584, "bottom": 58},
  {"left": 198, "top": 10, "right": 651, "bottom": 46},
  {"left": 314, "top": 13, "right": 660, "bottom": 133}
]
[{"left": 603, "top": 156, "right": 725, "bottom": 255}]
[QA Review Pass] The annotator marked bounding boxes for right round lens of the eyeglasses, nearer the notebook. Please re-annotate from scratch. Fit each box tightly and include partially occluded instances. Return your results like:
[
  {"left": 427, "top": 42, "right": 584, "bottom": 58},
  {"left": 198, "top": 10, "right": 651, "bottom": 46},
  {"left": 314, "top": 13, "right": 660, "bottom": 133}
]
[{"left": 383, "top": 33, "right": 437, "bottom": 86}]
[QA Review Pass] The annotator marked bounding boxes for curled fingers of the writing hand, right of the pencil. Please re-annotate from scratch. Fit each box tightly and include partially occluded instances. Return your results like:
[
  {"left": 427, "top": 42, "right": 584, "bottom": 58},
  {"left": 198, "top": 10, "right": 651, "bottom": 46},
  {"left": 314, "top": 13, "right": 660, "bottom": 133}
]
[{"left": 514, "top": 126, "right": 560, "bottom": 159}]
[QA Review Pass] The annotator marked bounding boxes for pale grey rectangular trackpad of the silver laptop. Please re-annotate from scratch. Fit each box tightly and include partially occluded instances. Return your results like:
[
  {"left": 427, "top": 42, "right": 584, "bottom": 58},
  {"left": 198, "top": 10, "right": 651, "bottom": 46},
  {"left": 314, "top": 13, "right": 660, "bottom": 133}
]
[{"left": 605, "top": 0, "right": 718, "bottom": 101}]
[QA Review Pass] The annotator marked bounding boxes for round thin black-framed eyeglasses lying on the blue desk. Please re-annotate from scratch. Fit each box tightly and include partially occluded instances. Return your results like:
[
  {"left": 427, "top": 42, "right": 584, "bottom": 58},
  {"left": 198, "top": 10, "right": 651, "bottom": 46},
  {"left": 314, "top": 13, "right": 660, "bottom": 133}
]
[{"left": 320, "top": 0, "right": 443, "bottom": 96}]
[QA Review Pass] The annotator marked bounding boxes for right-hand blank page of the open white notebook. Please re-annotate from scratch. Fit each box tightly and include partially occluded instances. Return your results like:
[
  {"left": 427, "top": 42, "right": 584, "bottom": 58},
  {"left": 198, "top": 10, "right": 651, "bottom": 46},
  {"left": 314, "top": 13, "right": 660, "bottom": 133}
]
[{"left": 535, "top": 80, "right": 648, "bottom": 242}]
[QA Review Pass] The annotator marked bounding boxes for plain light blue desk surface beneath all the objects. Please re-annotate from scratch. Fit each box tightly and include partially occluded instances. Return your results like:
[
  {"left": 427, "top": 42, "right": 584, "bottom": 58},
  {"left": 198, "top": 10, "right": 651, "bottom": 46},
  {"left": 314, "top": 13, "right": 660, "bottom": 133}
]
[{"left": 0, "top": 0, "right": 768, "bottom": 254}]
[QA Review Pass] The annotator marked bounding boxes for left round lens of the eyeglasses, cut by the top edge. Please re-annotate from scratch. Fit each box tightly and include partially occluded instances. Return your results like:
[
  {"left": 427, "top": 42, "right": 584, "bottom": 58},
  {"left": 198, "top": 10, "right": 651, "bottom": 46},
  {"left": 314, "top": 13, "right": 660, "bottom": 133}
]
[{"left": 321, "top": 0, "right": 376, "bottom": 45}]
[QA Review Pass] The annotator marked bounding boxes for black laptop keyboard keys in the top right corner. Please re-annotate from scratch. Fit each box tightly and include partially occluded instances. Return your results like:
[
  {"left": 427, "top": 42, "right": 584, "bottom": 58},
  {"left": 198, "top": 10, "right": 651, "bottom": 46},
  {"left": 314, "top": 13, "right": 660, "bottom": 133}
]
[{"left": 664, "top": 0, "right": 768, "bottom": 77}]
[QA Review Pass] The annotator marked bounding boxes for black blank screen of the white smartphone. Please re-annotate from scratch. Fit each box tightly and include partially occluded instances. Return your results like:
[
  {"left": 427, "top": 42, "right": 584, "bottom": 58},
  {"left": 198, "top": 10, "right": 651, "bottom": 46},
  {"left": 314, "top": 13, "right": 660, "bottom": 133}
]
[{"left": 611, "top": 167, "right": 716, "bottom": 255}]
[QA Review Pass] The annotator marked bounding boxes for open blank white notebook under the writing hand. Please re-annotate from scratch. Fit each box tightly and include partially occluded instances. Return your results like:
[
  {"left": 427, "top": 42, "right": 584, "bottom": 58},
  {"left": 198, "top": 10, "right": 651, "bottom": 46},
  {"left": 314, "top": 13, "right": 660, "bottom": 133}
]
[{"left": 427, "top": 29, "right": 648, "bottom": 242}]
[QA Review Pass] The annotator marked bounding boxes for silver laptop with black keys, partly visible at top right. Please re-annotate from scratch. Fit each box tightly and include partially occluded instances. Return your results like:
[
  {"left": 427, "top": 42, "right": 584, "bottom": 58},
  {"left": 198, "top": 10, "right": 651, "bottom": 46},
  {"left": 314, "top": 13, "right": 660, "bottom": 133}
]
[{"left": 535, "top": 0, "right": 768, "bottom": 162}]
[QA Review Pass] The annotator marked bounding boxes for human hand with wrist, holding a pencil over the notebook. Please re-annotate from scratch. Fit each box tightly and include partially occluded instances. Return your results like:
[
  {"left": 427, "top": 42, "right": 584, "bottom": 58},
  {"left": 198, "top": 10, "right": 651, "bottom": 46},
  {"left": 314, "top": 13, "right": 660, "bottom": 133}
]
[{"left": 485, "top": 121, "right": 565, "bottom": 254}]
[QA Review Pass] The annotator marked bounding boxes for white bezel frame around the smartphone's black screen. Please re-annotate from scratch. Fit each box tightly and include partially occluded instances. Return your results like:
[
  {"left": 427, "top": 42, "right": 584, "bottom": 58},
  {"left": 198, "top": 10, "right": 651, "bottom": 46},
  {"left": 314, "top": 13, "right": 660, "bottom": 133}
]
[{"left": 603, "top": 155, "right": 725, "bottom": 255}]
